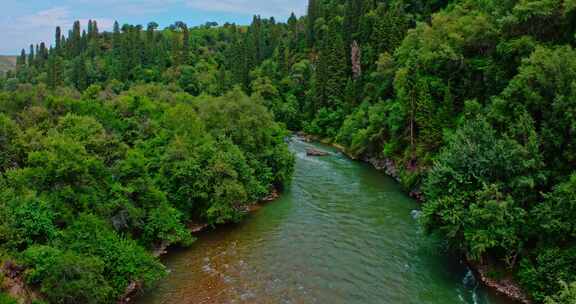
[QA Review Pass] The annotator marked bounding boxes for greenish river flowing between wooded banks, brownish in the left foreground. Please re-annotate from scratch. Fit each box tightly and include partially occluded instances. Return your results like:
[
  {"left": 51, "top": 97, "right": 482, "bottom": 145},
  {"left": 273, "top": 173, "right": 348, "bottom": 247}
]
[{"left": 136, "top": 139, "right": 509, "bottom": 304}]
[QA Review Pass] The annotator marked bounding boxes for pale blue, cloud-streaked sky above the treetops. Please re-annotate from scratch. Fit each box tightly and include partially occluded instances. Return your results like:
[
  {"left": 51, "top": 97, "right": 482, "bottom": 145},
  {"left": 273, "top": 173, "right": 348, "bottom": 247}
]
[{"left": 0, "top": 0, "right": 307, "bottom": 55}]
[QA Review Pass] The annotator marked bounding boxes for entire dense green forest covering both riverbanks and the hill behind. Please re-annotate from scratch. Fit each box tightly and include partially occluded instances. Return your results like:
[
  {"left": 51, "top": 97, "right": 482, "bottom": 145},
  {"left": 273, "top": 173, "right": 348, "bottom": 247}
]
[{"left": 0, "top": 0, "right": 576, "bottom": 304}]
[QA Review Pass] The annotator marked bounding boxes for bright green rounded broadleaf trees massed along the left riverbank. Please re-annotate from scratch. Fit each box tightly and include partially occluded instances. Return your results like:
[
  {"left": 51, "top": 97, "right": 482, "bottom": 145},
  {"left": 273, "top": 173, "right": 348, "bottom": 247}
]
[{"left": 0, "top": 85, "right": 293, "bottom": 303}]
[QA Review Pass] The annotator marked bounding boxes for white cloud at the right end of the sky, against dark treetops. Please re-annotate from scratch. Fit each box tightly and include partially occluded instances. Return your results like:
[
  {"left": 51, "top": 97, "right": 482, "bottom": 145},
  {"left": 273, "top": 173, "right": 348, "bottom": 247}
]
[{"left": 186, "top": 0, "right": 306, "bottom": 17}]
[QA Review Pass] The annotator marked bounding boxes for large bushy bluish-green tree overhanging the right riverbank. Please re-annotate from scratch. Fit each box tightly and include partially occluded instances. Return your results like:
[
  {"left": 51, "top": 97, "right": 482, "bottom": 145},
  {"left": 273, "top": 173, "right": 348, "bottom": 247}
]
[{"left": 423, "top": 120, "right": 538, "bottom": 266}]
